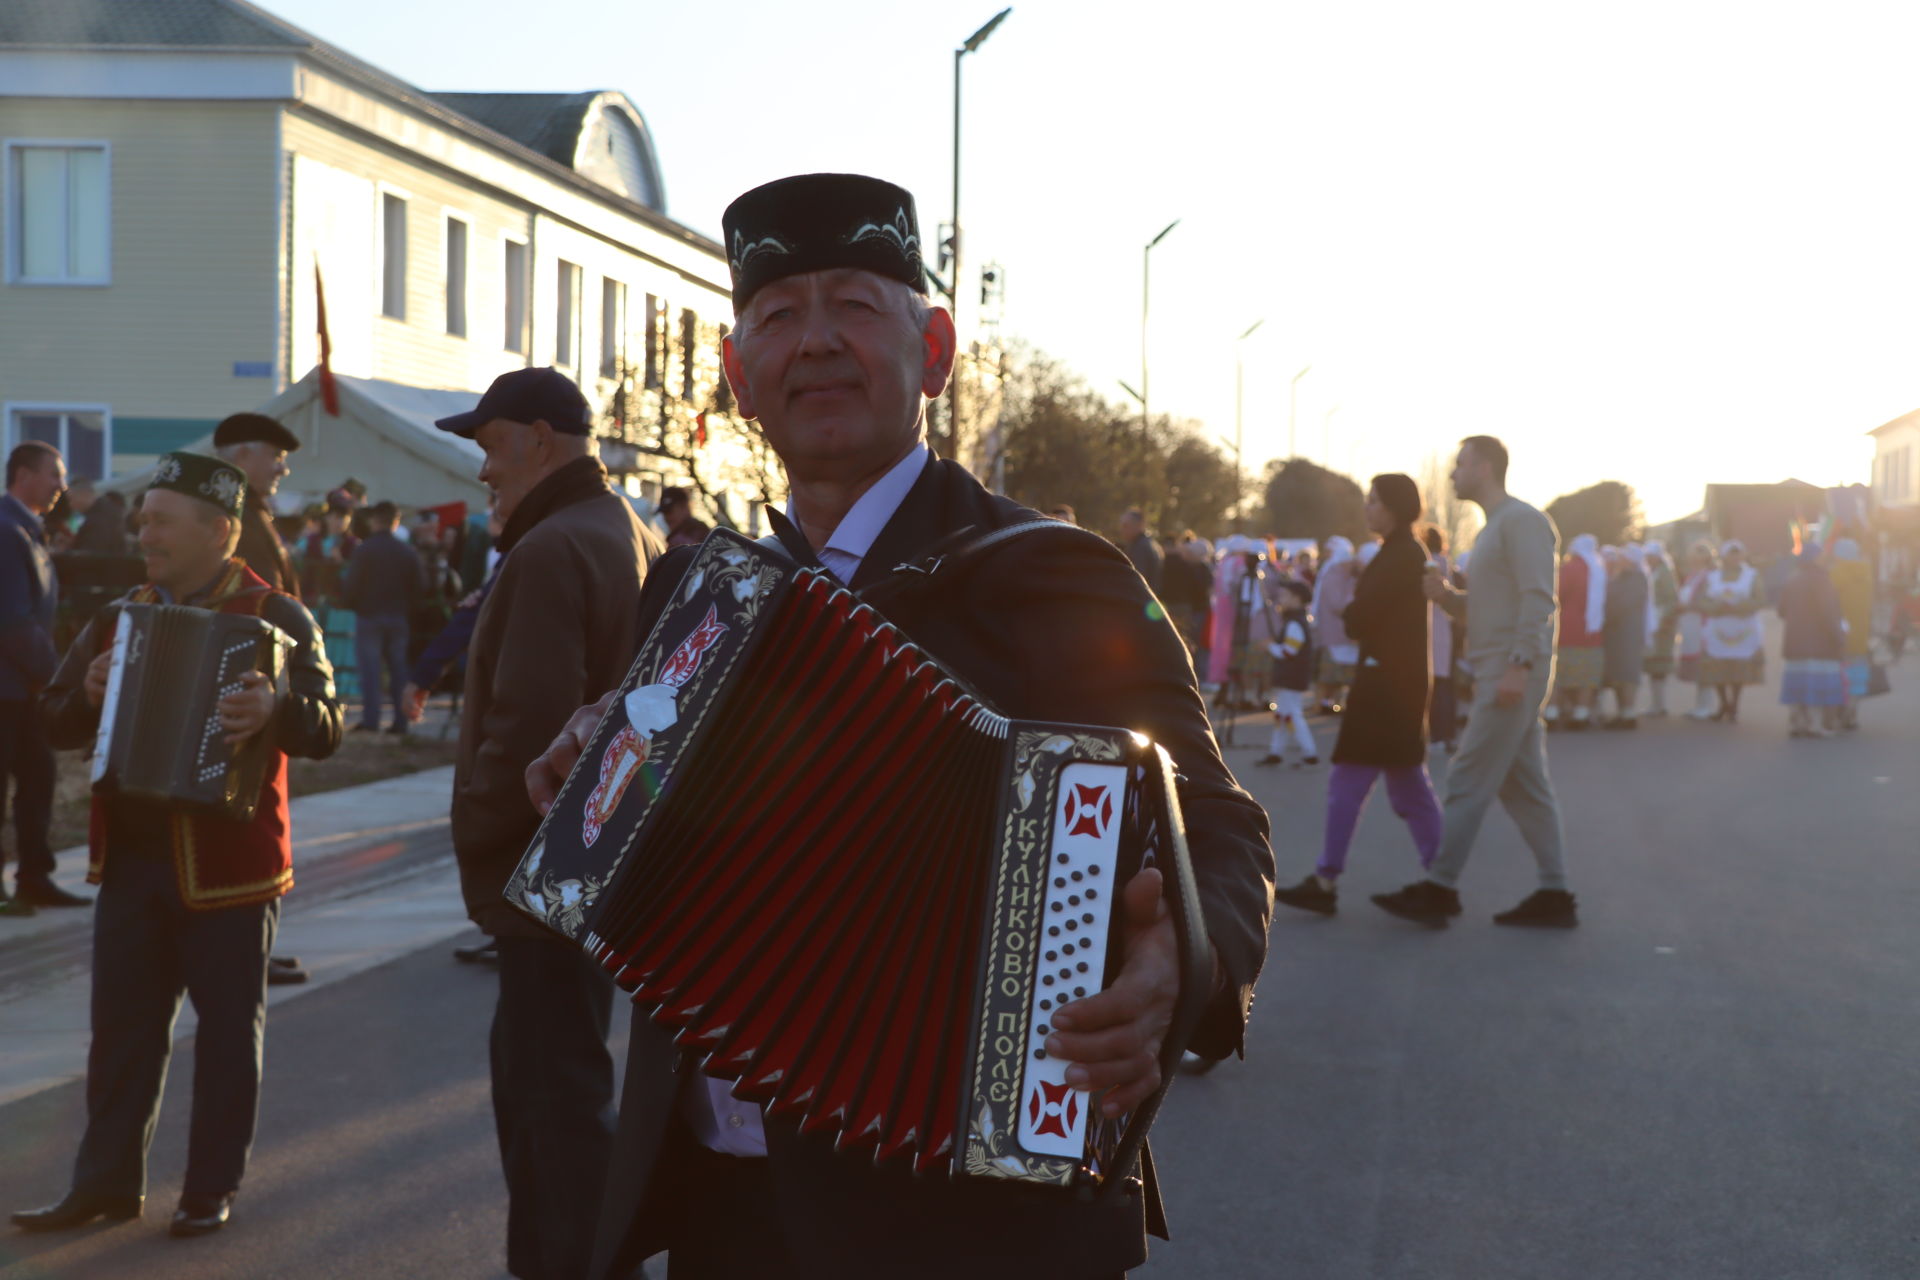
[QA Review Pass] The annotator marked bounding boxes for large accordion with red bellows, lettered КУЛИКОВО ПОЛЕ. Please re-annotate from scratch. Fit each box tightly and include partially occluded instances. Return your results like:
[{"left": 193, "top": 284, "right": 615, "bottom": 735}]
[{"left": 507, "top": 526, "right": 1212, "bottom": 1188}]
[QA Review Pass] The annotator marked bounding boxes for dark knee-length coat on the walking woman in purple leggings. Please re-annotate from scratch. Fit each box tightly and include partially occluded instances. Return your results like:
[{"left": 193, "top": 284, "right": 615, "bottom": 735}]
[{"left": 1332, "top": 530, "right": 1432, "bottom": 770}]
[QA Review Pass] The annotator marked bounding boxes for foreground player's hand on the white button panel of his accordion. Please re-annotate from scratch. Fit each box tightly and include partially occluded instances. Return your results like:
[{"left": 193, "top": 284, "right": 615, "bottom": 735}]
[{"left": 1046, "top": 867, "right": 1205, "bottom": 1117}]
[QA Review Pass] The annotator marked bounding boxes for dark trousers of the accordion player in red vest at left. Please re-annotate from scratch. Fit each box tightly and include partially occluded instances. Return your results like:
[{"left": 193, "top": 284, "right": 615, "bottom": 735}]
[{"left": 73, "top": 850, "right": 280, "bottom": 1196}]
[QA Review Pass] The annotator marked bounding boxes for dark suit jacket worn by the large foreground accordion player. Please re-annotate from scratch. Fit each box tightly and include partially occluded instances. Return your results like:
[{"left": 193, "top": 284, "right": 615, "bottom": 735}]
[{"left": 593, "top": 461, "right": 1273, "bottom": 1280}]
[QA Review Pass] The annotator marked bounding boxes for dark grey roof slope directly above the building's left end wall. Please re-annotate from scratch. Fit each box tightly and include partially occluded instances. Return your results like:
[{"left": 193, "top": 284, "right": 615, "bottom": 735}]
[{"left": 0, "top": 0, "right": 313, "bottom": 48}]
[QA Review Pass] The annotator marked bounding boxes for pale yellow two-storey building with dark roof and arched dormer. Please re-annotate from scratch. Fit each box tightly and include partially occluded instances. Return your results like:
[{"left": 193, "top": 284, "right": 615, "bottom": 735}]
[{"left": 0, "top": 0, "right": 732, "bottom": 521}]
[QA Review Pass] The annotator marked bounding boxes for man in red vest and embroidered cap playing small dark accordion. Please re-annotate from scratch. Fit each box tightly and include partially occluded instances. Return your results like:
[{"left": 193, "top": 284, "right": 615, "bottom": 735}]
[{"left": 13, "top": 453, "right": 340, "bottom": 1236}]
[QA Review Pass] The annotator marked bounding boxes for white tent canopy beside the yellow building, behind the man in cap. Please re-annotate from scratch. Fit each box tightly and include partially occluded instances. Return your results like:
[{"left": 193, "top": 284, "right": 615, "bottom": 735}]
[{"left": 104, "top": 368, "right": 488, "bottom": 510}]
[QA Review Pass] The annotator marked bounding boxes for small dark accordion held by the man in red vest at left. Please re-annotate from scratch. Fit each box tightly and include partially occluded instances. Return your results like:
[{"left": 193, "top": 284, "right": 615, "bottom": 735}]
[{"left": 92, "top": 604, "right": 294, "bottom": 821}]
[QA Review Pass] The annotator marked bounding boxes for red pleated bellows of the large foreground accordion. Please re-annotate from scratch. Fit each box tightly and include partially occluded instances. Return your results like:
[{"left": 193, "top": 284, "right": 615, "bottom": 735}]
[{"left": 595, "top": 576, "right": 1004, "bottom": 1169}]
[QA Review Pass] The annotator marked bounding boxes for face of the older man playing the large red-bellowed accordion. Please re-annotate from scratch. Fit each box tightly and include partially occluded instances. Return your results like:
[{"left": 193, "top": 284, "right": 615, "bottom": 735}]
[{"left": 726, "top": 269, "right": 954, "bottom": 482}]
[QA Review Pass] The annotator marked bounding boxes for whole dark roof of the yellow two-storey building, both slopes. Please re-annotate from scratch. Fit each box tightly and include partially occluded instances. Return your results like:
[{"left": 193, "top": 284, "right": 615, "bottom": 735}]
[{"left": 0, "top": 0, "right": 720, "bottom": 253}]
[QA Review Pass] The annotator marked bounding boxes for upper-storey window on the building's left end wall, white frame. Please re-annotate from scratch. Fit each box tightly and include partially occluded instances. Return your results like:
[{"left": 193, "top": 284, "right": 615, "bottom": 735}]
[{"left": 6, "top": 142, "right": 111, "bottom": 284}]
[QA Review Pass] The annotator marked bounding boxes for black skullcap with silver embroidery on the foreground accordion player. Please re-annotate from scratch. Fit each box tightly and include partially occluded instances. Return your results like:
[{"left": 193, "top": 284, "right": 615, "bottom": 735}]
[{"left": 720, "top": 173, "right": 925, "bottom": 311}]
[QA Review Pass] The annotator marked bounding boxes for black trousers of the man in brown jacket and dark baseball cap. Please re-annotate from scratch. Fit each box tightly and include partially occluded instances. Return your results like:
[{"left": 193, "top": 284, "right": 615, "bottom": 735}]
[{"left": 492, "top": 936, "right": 614, "bottom": 1280}]
